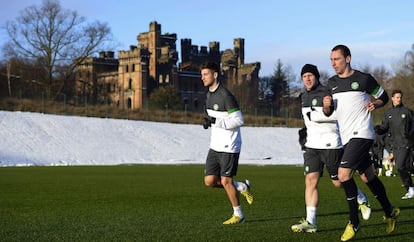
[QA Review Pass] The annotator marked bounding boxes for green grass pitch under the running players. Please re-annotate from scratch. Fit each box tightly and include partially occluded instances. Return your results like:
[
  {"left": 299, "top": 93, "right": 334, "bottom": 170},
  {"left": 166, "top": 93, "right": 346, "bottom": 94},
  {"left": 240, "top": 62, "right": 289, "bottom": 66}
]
[{"left": 0, "top": 165, "right": 414, "bottom": 242}]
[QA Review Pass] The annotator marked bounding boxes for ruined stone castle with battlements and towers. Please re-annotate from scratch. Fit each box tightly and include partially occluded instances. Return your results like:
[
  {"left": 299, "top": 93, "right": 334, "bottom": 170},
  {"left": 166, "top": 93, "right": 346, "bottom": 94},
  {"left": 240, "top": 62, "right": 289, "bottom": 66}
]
[{"left": 75, "top": 22, "right": 260, "bottom": 110}]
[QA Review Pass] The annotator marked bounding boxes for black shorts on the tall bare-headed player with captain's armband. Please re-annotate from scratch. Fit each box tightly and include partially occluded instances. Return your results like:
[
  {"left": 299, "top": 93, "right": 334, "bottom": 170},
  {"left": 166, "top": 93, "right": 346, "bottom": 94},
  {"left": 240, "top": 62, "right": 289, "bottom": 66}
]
[{"left": 339, "top": 138, "right": 374, "bottom": 174}]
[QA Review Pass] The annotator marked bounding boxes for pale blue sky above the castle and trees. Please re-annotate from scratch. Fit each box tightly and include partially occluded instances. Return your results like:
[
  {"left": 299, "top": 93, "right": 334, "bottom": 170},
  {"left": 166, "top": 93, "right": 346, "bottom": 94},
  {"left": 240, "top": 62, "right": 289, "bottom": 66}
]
[{"left": 0, "top": 0, "right": 414, "bottom": 76}]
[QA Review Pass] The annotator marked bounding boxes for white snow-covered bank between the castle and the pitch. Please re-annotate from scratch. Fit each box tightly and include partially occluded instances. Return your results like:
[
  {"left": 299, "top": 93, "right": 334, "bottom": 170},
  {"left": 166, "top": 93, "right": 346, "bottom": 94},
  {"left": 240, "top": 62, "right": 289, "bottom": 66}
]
[{"left": 0, "top": 111, "right": 303, "bottom": 166}]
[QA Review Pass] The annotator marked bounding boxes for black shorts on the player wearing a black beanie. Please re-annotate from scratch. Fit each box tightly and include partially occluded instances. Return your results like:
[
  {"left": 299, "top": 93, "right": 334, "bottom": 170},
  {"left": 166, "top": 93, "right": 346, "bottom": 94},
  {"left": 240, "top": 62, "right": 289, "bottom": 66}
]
[{"left": 303, "top": 148, "right": 343, "bottom": 180}]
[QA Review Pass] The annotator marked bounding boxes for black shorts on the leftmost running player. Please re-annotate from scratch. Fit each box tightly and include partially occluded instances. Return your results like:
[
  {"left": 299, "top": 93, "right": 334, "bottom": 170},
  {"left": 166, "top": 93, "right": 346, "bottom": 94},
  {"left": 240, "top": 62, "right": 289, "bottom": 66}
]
[{"left": 204, "top": 149, "right": 240, "bottom": 177}]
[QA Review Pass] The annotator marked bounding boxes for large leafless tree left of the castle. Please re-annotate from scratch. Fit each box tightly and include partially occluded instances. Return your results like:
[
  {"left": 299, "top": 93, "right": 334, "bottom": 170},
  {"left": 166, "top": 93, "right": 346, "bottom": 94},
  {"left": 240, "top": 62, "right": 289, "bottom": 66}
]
[{"left": 3, "top": 0, "right": 112, "bottom": 96}]
